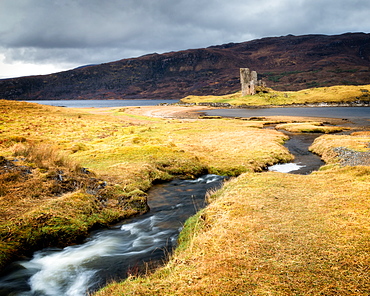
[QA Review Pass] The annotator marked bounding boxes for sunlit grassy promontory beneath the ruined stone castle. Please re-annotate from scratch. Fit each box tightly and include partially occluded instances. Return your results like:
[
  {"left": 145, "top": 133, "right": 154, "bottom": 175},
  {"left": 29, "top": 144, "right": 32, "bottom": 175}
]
[{"left": 181, "top": 85, "right": 370, "bottom": 106}]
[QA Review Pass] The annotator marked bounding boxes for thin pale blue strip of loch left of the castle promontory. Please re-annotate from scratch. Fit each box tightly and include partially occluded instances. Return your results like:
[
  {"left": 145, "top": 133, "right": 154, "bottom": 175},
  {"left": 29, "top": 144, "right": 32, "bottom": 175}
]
[{"left": 27, "top": 100, "right": 177, "bottom": 108}]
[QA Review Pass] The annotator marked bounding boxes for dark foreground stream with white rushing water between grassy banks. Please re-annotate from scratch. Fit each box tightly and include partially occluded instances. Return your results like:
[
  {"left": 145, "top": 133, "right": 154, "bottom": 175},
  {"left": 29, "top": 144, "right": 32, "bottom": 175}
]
[{"left": 0, "top": 175, "right": 224, "bottom": 296}]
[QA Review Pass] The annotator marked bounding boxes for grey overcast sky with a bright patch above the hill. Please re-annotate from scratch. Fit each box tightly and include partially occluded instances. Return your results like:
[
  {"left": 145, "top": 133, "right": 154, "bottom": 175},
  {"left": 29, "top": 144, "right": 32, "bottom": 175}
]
[{"left": 0, "top": 0, "right": 370, "bottom": 78}]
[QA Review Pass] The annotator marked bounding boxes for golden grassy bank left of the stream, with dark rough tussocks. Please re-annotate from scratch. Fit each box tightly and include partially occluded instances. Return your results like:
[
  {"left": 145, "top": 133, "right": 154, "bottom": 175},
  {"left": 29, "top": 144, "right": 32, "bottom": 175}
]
[{"left": 0, "top": 101, "right": 292, "bottom": 266}]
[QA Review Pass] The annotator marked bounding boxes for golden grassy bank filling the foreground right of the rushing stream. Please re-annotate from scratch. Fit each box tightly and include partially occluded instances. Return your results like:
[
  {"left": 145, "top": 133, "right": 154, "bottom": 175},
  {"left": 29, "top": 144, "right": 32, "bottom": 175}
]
[{"left": 96, "top": 167, "right": 370, "bottom": 296}]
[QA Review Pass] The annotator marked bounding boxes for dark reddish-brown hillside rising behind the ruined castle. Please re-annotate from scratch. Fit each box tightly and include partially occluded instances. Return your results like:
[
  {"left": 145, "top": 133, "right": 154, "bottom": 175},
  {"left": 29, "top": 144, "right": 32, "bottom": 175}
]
[{"left": 0, "top": 33, "right": 370, "bottom": 100}]
